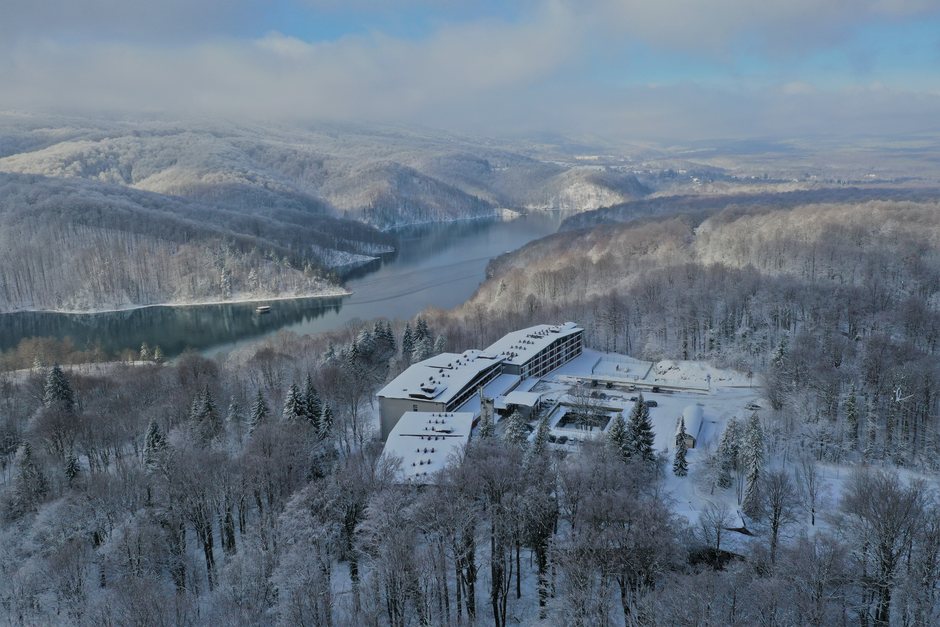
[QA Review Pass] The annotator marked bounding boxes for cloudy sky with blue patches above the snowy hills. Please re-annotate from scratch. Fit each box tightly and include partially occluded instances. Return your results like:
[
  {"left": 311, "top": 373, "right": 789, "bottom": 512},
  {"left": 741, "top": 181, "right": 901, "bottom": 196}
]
[{"left": 0, "top": 0, "right": 940, "bottom": 142}]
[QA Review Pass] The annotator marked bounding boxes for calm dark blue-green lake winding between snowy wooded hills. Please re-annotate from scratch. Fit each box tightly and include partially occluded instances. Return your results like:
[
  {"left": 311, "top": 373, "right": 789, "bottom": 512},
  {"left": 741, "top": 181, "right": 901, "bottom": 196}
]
[{"left": 0, "top": 211, "right": 570, "bottom": 357}]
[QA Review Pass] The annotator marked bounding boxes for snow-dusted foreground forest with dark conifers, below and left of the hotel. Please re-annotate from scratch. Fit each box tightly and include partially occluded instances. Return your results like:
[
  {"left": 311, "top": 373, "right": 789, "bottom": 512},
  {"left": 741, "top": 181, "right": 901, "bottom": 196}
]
[{"left": 0, "top": 312, "right": 940, "bottom": 627}]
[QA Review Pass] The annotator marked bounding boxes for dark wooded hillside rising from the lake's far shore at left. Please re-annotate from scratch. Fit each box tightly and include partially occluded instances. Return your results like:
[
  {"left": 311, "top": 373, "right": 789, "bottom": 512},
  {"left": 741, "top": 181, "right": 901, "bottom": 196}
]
[{"left": 0, "top": 174, "right": 393, "bottom": 311}]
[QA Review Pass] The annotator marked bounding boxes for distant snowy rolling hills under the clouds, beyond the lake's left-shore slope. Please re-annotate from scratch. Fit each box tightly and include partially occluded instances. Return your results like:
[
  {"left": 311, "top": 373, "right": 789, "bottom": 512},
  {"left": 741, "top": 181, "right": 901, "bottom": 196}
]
[{"left": 0, "top": 113, "right": 648, "bottom": 229}]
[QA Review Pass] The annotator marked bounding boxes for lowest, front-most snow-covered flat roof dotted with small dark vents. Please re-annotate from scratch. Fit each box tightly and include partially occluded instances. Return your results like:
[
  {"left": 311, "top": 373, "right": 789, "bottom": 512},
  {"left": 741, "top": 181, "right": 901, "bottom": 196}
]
[{"left": 384, "top": 411, "right": 473, "bottom": 483}]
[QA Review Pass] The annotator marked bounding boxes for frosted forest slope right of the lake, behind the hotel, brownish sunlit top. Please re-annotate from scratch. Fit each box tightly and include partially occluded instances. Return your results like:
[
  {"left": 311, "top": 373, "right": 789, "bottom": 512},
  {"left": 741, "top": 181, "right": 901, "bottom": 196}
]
[{"left": 447, "top": 194, "right": 940, "bottom": 470}]
